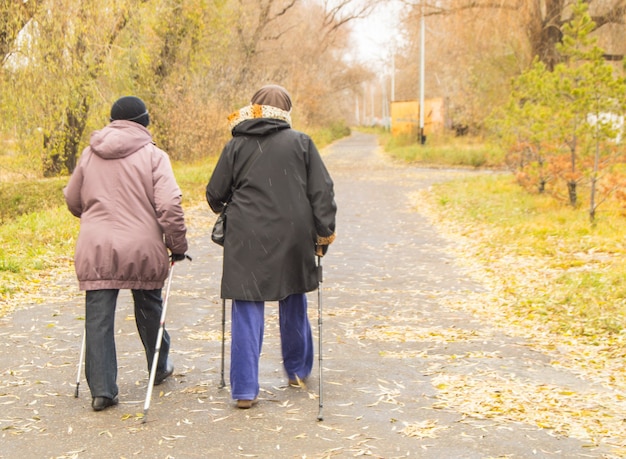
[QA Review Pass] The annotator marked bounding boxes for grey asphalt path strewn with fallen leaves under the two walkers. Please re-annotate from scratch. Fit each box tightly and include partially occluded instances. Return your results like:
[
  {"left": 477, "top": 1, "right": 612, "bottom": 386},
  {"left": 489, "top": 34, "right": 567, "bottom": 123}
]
[{"left": 0, "top": 133, "right": 611, "bottom": 459}]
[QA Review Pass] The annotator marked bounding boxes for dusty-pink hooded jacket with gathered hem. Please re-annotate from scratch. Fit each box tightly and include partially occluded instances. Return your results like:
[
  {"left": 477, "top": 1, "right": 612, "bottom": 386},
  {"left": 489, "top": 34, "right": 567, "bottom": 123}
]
[{"left": 64, "top": 120, "right": 187, "bottom": 290}]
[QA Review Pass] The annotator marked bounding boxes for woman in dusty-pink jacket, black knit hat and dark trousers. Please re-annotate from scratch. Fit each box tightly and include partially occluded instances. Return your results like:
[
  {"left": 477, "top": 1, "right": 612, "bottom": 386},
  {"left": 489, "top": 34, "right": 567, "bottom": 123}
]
[{"left": 64, "top": 96, "right": 187, "bottom": 411}]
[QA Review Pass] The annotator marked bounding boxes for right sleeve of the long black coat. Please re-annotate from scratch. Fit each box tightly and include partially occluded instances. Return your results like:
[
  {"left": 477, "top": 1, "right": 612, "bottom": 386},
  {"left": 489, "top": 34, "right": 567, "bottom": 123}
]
[{"left": 307, "top": 138, "right": 337, "bottom": 239}]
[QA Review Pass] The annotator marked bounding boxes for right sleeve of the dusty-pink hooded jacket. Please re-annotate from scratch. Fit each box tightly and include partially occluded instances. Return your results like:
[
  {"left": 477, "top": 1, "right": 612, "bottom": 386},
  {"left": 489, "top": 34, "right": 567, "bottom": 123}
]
[{"left": 152, "top": 147, "right": 188, "bottom": 254}]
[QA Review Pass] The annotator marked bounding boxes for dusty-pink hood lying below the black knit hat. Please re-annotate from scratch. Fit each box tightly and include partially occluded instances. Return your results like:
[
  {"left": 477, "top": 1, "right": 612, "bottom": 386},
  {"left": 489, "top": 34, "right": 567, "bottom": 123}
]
[{"left": 89, "top": 120, "right": 152, "bottom": 159}]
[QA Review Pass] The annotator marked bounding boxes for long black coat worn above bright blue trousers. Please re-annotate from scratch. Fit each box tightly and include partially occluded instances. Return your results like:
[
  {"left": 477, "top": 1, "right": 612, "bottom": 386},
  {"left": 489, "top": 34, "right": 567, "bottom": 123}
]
[{"left": 206, "top": 118, "right": 337, "bottom": 301}]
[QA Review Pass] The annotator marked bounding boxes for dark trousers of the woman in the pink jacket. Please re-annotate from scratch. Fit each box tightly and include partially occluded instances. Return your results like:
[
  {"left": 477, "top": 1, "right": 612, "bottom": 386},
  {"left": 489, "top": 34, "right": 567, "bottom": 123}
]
[{"left": 85, "top": 289, "right": 170, "bottom": 398}]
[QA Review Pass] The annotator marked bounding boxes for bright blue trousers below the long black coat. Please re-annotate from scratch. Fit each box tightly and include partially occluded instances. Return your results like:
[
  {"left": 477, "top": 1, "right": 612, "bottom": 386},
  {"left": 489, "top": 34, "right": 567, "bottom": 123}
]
[{"left": 230, "top": 294, "right": 313, "bottom": 400}]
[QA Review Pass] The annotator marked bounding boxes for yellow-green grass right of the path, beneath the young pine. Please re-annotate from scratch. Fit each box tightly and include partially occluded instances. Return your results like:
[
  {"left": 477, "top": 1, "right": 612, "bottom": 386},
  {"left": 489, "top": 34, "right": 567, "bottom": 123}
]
[{"left": 420, "top": 174, "right": 626, "bottom": 341}]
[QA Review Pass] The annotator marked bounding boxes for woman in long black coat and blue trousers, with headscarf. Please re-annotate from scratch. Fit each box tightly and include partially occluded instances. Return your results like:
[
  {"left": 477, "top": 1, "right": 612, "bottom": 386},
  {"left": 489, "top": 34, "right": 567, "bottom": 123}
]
[{"left": 206, "top": 85, "right": 337, "bottom": 408}]
